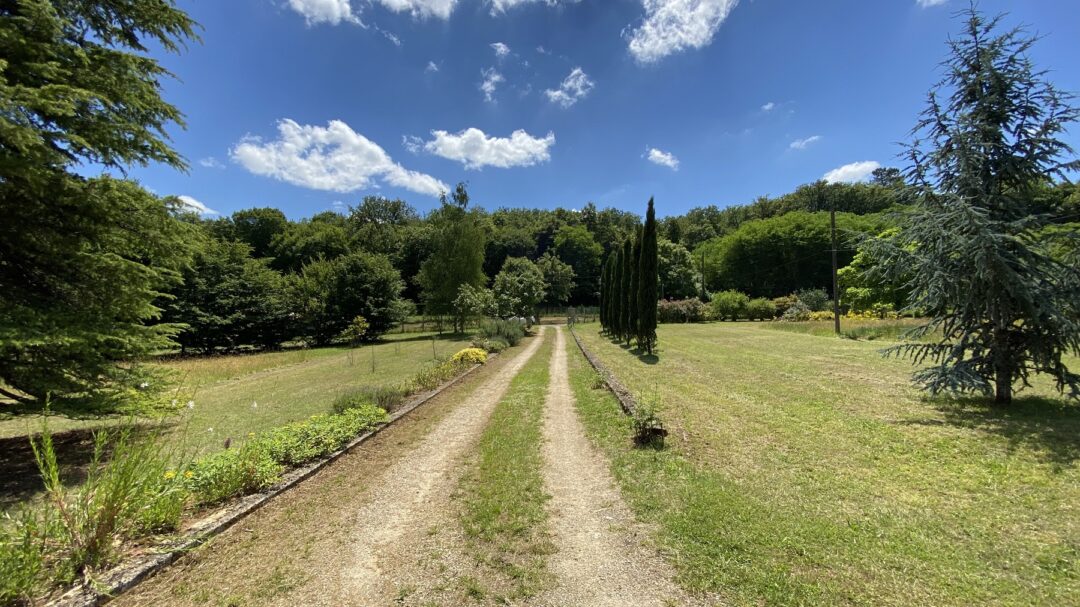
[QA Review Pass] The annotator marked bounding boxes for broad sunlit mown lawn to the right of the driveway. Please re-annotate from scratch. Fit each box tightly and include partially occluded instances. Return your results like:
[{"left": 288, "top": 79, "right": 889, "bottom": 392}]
[{"left": 570, "top": 323, "right": 1080, "bottom": 606}]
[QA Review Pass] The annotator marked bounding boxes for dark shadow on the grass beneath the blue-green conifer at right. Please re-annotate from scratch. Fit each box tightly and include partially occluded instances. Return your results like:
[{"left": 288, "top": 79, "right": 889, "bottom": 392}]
[{"left": 910, "top": 396, "right": 1080, "bottom": 466}]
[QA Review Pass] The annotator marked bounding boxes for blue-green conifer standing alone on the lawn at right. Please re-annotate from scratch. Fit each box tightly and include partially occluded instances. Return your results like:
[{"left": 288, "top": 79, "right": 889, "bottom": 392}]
[{"left": 865, "top": 5, "right": 1080, "bottom": 404}]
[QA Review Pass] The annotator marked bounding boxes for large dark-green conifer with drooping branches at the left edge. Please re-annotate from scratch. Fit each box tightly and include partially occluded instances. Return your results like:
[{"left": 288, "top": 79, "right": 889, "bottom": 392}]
[{"left": 0, "top": 0, "right": 194, "bottom": 400}]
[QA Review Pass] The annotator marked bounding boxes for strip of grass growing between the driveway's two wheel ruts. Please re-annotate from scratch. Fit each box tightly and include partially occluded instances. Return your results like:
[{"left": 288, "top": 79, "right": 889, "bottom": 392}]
[{"left": 458, "top": 337, "right": 554, "bottom": 605}]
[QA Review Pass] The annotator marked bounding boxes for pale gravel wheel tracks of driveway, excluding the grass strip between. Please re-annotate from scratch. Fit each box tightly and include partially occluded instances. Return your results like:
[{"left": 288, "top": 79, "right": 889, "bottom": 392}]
[{"left": 111, "top": 327, "right": 693, "bottom": 607}]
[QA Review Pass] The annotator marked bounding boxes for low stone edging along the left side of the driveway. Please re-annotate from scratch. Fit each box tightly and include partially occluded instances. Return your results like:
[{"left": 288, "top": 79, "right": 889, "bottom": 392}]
[{"left": 48, "top": 353, "right": 498, "bottom": 607}]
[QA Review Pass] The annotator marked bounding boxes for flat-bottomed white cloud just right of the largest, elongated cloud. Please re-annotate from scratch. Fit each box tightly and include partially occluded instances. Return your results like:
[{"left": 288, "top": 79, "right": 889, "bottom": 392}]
[{"left": 423, "top": 129, "right": 555, "bottom": 168}]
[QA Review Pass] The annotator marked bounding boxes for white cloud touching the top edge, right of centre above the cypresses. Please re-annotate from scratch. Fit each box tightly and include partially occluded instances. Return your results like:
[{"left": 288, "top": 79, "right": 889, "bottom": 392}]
[{"left": 629, "top": 0, "right": 739, "bottom": 64}]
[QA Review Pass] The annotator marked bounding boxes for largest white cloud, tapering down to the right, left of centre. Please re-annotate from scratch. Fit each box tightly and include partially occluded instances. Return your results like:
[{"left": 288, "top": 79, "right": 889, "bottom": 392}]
[{"left": 230, "top": 119, "right": 449, "bottom": 195}]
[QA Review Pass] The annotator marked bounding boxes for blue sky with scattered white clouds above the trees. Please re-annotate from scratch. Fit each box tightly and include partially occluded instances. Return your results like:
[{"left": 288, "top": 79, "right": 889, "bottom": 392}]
[{"left": 131, "top": 0, "right": 1080, "bottom": 218}]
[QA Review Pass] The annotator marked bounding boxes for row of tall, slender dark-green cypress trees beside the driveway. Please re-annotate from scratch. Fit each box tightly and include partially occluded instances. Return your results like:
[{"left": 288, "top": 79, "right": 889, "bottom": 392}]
[{"left": 600, "top": 199, "right": 658, "bottom": 354}]
